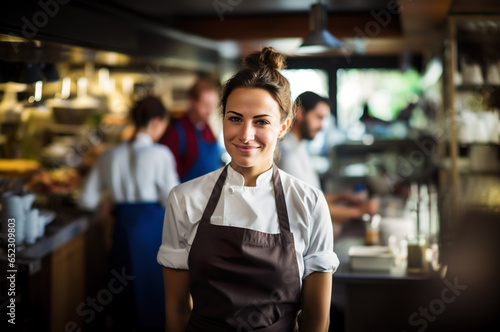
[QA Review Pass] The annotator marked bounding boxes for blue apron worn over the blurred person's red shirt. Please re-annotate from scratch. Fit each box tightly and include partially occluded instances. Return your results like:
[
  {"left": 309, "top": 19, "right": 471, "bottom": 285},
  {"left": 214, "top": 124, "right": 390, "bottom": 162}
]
[{"left": 175, "top": 122, "right": 222, "bottom": 182}]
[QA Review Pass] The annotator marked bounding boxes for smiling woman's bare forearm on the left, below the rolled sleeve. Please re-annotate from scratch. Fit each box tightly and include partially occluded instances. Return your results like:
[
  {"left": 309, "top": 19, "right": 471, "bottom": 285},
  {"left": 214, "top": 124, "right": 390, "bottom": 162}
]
[{"left": 163, "top": 267, "right": 193, "bottom": 332}]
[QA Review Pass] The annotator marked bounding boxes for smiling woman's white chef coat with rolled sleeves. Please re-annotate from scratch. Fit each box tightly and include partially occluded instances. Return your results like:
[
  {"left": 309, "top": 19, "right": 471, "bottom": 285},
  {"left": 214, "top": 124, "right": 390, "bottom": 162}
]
[{"left": 158, "top": 166, "right": 339, "bottom": 282}]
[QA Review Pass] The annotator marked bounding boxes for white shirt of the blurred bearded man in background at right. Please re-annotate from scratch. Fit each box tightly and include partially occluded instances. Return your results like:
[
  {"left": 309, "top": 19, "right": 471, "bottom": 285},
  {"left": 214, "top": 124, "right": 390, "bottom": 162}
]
[{"left": 276, "top": 133, "right": 321, "bottom": 189}]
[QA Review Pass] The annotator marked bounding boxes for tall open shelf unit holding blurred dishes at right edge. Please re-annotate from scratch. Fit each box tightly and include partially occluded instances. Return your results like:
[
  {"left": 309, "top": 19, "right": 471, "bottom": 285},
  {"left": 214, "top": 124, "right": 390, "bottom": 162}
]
[{"left": 439, "top": 14, "right": 500, "bottom": 228}]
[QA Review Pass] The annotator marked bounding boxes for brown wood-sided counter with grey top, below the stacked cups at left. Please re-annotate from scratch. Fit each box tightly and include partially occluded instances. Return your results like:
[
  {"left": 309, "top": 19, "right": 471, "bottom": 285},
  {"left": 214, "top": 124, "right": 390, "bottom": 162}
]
[{"left": 0, "top": 206, "right": 98, "bottom": 331}]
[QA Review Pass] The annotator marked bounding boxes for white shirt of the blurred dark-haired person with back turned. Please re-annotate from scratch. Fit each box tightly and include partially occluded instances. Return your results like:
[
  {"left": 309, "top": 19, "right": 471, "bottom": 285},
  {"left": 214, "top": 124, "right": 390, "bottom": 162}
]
[{"left": 79, "top": 133, "right": 179, "bottom": 209}]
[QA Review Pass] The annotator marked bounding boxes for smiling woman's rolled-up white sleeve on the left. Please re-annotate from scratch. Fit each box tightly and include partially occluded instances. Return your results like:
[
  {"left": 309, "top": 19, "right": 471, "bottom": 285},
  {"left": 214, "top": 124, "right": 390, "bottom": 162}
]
[{"left": 157, "top": 188, "right": 189, "bottom": 270}]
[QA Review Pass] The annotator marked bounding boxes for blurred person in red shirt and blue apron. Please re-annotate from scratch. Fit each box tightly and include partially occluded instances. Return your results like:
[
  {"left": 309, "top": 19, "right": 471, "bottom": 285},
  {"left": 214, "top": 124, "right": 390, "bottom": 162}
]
[{"left": 160, "top": 79, "right": 222, "bottom": 182}]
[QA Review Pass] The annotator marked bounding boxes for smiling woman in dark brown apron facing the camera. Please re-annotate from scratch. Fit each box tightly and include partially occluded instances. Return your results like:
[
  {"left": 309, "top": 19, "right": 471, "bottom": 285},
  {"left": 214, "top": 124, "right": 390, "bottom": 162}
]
[{"left": 158, "top": 48, "right": 338, "bottom": 332}]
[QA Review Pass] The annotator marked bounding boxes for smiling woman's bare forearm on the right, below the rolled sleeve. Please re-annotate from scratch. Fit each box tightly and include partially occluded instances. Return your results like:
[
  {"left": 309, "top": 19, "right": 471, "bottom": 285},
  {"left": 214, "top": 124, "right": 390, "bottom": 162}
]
[{"left": 300, "top": 272, "right": 332, "bottom": 332}]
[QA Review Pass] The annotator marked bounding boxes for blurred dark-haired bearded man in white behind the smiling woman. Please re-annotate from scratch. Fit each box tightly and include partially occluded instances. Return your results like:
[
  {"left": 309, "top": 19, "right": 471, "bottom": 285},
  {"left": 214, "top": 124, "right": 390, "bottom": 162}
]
[{"left": 276, "top": 91, "right": 378, "bottom": 235}]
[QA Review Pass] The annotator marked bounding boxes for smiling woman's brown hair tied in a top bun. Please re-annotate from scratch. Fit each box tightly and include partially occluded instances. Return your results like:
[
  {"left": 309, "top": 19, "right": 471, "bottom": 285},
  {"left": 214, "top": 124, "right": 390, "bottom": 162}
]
[{"left": 221, "top": 47, "right": 295, "bottom": 122}]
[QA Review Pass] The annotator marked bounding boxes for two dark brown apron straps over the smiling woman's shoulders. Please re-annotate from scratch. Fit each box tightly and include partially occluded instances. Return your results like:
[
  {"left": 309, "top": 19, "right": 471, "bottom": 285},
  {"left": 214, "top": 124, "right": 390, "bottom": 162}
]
[{"left": 201, "top": 163, "right": 290, "bottom": 234}]
